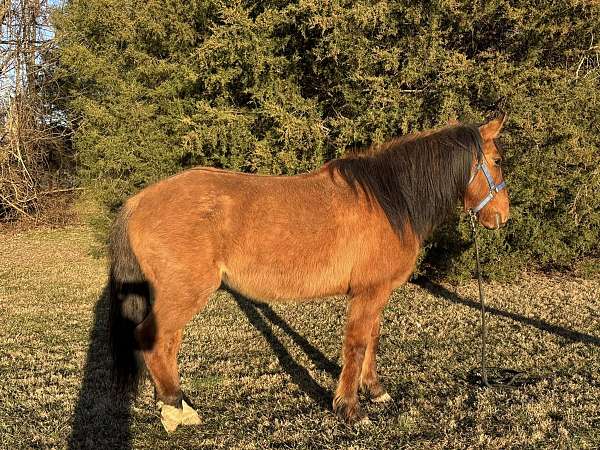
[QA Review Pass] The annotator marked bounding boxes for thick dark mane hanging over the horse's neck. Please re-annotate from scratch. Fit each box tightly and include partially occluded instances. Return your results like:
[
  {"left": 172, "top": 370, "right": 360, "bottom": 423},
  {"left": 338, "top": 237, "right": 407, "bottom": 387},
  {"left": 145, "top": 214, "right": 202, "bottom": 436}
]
[{"left": 327, "top": 125, "right": 483, "bottom": 240}]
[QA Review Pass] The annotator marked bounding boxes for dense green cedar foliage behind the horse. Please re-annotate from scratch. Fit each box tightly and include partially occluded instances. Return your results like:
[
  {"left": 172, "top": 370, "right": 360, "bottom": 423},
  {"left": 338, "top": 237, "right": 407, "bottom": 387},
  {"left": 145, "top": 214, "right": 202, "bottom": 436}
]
[{"left": 55, "top": 0, "right": 600, "bottom": 276}]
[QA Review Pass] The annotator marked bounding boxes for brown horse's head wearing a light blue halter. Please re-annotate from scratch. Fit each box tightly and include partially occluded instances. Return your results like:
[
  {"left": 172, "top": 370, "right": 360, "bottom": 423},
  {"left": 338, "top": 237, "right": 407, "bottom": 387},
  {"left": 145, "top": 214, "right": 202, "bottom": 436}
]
[{"left": 464, "top": 115, "right": 509, "bottom": 229}]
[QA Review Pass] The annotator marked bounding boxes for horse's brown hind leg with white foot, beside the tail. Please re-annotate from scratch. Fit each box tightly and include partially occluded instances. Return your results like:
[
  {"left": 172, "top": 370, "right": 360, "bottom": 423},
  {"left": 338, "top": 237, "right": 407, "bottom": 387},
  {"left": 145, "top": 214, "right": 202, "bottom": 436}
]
[{"left": 136, "top": 280, "right": 219, "bottom": 432}]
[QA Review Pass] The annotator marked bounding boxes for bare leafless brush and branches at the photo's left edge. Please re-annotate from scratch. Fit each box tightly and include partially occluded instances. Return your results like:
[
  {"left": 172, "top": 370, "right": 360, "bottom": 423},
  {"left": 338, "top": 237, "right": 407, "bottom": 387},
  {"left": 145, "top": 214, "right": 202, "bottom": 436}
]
[{"left": 0, "top": 0, "right": 67, "bottom": 220}]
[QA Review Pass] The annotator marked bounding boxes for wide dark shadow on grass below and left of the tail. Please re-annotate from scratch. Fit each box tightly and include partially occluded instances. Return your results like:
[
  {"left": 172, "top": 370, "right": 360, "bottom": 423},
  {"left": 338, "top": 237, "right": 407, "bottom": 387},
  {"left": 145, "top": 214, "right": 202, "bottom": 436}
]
[{"left": 68, "top": 288, "right": 131, "bottom": 449}]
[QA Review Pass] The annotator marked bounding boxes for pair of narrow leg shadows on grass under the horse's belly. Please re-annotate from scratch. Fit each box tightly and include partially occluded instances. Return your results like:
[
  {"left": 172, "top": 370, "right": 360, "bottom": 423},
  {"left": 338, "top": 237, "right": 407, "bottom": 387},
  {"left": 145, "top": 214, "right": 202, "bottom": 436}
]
[{"left": 229, "top": 291, "right": 341, "bottom": 409}]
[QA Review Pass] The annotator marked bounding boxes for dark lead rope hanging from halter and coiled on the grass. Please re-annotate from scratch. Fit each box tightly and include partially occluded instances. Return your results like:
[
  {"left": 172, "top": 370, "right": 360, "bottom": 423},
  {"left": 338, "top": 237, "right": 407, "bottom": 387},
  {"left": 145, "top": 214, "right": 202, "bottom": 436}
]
[{"left": 469, "top": 210, "right": 537, "bottom": 389}]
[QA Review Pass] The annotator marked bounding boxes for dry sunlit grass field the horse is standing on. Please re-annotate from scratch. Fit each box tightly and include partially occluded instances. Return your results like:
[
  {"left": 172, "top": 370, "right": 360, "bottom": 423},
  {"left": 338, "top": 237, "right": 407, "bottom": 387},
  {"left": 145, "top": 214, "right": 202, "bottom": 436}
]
[{"left": 0, "top": 227, "right": 600, "bottom": 449}]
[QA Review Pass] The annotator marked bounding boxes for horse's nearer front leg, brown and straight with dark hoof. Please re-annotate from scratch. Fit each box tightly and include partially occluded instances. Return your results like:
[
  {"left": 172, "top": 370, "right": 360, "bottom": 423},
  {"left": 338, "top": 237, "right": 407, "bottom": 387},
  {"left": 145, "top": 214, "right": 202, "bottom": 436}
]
[{"left": 333, "top": 287, "right": 390, "bottom": 423}]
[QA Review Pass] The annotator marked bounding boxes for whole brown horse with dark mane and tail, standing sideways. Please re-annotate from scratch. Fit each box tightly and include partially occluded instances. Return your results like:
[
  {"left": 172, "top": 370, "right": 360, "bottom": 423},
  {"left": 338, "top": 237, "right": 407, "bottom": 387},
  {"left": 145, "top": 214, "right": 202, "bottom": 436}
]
[{"left": 109, "top": 117, "right": 509, "bottom": 431}]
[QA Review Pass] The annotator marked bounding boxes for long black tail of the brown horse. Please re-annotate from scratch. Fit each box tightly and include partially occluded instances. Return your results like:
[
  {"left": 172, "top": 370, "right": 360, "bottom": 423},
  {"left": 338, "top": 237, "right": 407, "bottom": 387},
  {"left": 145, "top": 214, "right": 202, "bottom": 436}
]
[{"left": 108, "top": 202, "right": 150, "bottom": 394}]
